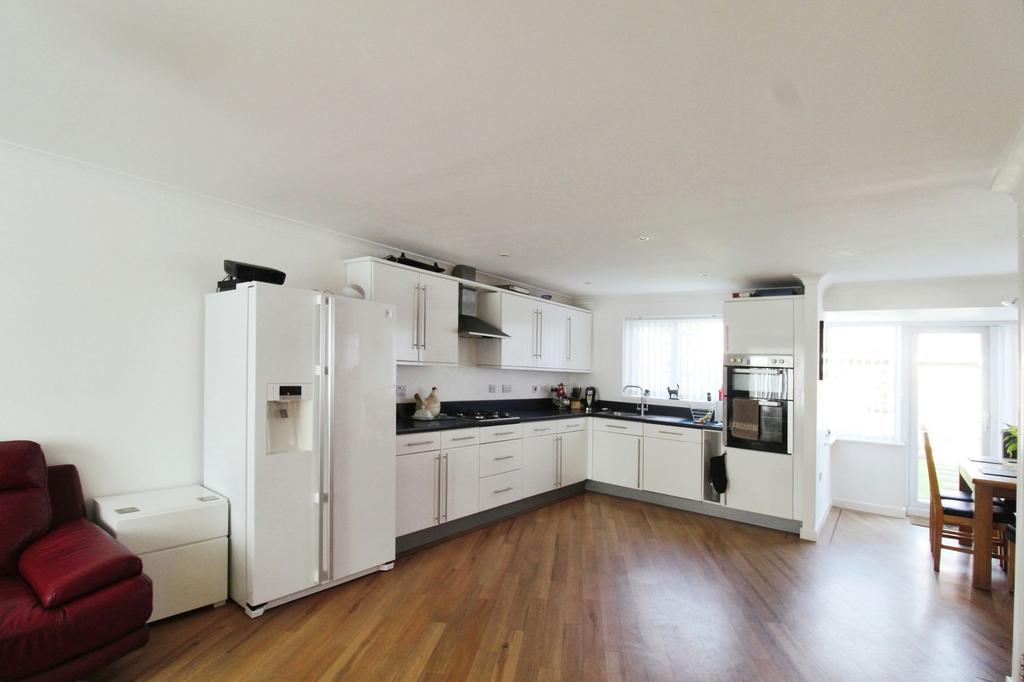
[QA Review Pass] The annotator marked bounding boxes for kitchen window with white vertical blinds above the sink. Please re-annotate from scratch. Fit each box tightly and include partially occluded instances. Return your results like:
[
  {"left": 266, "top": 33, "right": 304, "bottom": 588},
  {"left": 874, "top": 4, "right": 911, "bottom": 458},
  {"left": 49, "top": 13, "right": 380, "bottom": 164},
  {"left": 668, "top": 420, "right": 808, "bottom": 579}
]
[{"left": 623, "top": 317, "right": 725, "bottom": 400}]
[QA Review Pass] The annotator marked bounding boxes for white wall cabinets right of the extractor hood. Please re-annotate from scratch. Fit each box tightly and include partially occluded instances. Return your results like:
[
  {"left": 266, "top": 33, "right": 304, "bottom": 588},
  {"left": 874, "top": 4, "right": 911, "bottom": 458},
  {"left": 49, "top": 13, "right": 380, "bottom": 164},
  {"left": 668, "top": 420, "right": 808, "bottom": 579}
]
[{"left": 476, "top": 291, "right": 592, "bottom": 372}]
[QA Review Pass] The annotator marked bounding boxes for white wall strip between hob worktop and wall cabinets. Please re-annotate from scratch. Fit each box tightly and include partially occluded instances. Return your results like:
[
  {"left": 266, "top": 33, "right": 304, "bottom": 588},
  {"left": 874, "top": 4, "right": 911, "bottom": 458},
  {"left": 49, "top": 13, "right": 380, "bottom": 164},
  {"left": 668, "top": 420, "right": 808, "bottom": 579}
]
[{"left": 398, "top": 339, "right": 573, "bottom": 409}]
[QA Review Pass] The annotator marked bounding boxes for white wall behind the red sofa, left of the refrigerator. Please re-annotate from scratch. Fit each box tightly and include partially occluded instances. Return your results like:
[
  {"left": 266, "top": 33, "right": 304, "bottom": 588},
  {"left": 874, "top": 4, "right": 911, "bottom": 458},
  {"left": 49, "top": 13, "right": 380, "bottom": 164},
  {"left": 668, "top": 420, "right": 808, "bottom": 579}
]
[{"left": 0, "top": 144, "right": 399, "bottom": 497}]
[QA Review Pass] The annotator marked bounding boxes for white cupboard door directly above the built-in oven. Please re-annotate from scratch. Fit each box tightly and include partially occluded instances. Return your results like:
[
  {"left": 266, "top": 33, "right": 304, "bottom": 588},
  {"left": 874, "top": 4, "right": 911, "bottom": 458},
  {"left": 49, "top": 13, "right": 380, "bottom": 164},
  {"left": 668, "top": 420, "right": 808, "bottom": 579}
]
[{"left": 722, "top": 297, "right": 797, "bottom": 355}]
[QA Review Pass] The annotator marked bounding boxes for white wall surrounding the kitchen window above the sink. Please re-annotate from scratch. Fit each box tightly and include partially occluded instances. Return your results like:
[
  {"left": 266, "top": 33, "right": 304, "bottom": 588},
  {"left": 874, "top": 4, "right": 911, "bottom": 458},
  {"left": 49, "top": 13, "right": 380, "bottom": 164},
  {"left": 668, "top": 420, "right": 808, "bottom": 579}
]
[{"left": 577, "top": 291, "right": 731, "bottom": 417}]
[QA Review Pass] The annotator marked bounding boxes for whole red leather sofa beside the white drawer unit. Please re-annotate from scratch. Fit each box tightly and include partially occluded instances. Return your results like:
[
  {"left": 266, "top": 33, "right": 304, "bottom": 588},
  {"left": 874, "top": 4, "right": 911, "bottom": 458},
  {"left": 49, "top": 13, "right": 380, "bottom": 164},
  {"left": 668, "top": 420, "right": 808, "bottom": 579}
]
[{"left": 0, "top": 440, "right": 153, "bottom": 682}]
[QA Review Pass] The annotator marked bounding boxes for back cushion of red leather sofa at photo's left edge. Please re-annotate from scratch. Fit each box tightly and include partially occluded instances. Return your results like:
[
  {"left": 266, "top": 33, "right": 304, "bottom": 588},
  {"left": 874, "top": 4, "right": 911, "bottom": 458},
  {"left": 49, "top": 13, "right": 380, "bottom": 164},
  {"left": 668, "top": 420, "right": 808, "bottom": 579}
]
[{"left": 0, "top": 440, "right": 50, "bottom": 576}]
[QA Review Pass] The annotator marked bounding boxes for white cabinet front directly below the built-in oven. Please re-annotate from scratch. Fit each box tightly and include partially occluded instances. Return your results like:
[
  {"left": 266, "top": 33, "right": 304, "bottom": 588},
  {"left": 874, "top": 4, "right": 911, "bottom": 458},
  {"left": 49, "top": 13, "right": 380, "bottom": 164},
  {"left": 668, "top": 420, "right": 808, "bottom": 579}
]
[{"left": 725, "top": 447, "right": 793, "bottom": 519}]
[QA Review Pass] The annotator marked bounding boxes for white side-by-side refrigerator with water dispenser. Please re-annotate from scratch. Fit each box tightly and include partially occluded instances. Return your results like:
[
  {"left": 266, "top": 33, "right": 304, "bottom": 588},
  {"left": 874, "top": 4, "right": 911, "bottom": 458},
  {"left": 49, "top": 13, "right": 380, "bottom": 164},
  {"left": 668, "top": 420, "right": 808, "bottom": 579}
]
[{"left": 203, "top": 283, "right": 395, "bottom": 616}]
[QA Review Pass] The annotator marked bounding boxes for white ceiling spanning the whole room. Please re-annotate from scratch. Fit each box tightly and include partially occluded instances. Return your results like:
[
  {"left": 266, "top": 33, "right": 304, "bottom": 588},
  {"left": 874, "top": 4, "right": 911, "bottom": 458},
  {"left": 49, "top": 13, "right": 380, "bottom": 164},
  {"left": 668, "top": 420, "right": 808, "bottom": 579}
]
[{"left": 0, "top": 0, "right": 1024, "bottom": 295}]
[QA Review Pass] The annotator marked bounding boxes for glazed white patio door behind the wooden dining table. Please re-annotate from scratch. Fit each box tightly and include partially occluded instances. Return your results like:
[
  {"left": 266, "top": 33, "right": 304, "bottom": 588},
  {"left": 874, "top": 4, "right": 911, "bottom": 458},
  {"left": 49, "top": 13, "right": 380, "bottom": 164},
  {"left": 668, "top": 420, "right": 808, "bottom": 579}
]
[{"left": 907, "top": 327, "right": 990, "bottom": 514}]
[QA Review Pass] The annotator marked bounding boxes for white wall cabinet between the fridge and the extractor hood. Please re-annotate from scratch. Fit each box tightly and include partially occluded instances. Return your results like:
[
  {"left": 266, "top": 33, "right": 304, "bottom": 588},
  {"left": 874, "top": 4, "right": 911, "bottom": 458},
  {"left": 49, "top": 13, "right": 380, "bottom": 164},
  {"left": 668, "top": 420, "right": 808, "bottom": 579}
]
[{"left": 346, "top": 258, "right": 459, "bottom": 365}]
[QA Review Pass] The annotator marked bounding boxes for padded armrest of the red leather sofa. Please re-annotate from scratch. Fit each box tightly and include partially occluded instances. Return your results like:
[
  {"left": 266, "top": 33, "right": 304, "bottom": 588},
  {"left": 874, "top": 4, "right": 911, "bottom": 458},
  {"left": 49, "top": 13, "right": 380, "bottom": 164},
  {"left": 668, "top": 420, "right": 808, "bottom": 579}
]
[{"left": 17, "top": 518, "right": 142, "bottom": 608}]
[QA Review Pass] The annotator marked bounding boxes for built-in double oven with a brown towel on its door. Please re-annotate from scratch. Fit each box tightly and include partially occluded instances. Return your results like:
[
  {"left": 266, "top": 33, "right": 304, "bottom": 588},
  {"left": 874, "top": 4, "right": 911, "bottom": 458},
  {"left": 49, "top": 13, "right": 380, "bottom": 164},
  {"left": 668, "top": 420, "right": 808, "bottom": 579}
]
[{"left": 724, "top": 354, "right": 795, "bottom": 455}]
